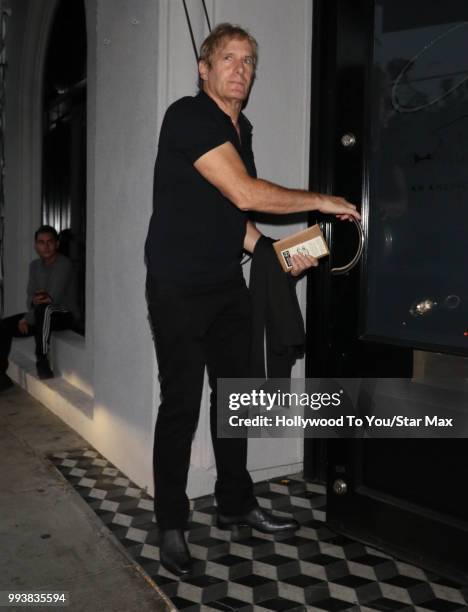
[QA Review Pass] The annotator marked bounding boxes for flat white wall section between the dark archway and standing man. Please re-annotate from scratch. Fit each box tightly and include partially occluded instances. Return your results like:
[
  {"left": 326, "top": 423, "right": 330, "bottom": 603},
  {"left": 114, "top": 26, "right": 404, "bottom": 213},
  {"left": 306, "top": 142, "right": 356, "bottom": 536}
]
[{"left": 88, "top": 0, "right": 159, "bottom": 486}]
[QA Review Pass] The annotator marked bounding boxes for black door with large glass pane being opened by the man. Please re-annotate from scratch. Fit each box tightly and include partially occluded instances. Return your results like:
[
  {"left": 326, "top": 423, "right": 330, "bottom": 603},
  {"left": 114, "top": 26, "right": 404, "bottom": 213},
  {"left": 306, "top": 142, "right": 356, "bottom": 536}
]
[{"left": 304, "top": 0, "right": 468, "bottom": 581}]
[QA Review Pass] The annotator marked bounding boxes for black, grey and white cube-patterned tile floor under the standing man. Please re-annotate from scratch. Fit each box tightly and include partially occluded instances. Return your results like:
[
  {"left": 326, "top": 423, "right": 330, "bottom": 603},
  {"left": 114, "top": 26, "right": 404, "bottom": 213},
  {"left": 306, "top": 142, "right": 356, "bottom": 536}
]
[{"left": 49, "top": 448, "right": 468, "bottom": 612}]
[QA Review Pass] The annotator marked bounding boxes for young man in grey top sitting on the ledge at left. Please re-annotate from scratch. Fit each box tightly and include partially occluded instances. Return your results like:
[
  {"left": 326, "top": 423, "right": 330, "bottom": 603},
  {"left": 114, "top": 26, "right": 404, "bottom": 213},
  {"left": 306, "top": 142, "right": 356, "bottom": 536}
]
[{"left": 0, "top": 225, "right": 78, "bottom": 391}]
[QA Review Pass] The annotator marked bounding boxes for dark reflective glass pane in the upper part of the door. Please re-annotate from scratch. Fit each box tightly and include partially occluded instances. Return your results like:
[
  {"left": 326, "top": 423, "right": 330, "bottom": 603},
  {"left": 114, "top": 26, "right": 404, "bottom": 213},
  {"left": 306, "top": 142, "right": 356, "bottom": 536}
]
[{"left": 366, "top": 0, "right": 468, "bottom": 352}]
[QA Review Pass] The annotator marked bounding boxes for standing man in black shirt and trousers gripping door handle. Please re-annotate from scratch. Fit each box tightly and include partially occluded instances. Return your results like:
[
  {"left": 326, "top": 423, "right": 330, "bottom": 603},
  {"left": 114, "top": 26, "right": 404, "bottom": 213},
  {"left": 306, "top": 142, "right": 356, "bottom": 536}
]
[{"left": 145, "top": 24, "right": 359, "bottom": 575}]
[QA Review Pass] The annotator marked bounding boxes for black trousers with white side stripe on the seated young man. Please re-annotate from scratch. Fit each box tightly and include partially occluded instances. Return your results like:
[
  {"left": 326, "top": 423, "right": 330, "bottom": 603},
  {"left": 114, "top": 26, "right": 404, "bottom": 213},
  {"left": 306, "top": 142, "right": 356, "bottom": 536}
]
[{"left": 0, "top": 304, "right": 73, "bottom": 373}]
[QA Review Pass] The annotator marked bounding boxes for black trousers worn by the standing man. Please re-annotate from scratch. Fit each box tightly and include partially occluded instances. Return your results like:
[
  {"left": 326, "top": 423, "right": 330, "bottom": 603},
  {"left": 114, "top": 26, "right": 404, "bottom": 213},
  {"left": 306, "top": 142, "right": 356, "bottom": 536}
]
[{"left": 147, "top": 276, "right": 256, "bottom": 529}]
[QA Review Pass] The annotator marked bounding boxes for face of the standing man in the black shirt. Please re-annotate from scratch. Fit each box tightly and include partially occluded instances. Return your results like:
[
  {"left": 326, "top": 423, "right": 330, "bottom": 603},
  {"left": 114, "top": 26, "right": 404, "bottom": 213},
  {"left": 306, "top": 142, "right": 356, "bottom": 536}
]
[{"left": 199, "top": 38, "right": 255, "bottom": 103}]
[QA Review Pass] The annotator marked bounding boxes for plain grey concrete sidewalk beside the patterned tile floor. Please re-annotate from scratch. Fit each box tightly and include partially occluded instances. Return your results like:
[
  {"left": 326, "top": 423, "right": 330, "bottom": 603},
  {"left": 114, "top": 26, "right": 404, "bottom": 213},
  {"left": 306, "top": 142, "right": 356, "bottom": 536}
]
[{"left": 0, "top": 386, "right": 173, "bottom": 612}]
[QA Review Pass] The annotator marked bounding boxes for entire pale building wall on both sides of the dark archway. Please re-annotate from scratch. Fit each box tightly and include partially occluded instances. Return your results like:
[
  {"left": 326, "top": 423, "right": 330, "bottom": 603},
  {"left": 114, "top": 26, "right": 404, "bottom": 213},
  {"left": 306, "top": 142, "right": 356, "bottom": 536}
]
[{"left": 7, "top": 0, "right": 312, "bottom": 496}]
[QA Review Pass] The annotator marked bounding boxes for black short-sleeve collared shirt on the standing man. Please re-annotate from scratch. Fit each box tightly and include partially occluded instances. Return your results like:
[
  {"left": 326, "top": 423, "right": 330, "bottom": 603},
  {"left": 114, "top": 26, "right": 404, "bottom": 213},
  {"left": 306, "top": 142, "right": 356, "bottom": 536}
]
[{"left": 145, "top": 92, "right": 256, "bottom": 285}]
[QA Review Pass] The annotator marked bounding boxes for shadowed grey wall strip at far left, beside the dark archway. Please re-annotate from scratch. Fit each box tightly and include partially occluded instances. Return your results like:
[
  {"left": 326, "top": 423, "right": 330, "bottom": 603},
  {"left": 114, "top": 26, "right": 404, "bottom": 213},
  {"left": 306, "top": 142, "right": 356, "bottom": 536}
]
[{"left": 4, "top": 0, "right": 54, "bottom": 315}]
